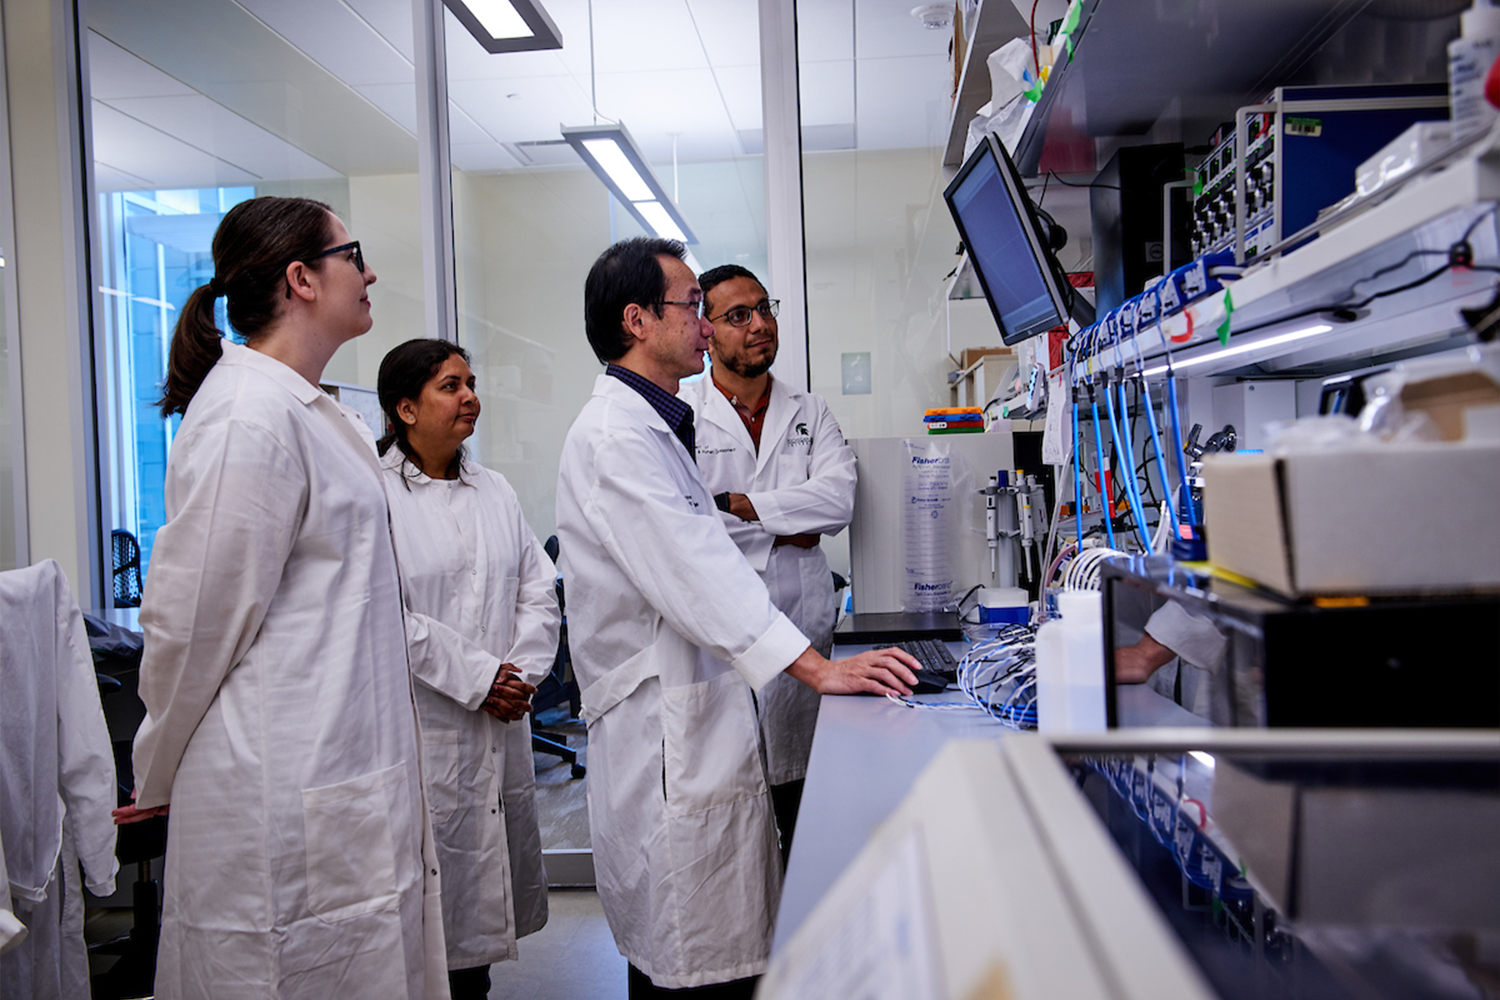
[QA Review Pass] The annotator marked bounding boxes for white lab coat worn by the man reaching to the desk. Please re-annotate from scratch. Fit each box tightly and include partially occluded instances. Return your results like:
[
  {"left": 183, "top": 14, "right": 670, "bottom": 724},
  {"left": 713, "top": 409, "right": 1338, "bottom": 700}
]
[{"left": 558, "top": 375, "right": 809, "bottom": 988}]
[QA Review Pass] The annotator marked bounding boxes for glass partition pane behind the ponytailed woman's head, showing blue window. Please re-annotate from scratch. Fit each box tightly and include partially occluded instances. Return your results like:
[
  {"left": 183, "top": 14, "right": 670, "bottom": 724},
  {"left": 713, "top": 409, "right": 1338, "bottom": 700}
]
[{"left": 86, "top": 0, "right": 425, "bottom": 571}]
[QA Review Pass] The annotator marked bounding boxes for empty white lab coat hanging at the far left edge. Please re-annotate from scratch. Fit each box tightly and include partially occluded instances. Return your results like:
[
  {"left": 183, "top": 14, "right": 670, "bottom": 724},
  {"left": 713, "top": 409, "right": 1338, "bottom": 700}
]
[{"left": 0, "top": 559, "right": 120, "bottom": 1000}]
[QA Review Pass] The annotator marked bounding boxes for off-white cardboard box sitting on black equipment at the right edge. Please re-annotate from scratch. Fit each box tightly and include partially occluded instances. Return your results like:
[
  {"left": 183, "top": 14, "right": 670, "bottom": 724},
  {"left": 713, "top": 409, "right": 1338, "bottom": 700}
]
[{"left": 1203, "top": 441, "right": 1500, "bottom": 597}]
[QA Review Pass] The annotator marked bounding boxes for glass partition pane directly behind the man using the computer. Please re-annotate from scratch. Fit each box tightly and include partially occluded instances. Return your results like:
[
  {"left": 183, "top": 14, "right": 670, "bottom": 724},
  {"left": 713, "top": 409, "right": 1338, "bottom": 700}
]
[{"left": 444, "top": 0, "right": 767, "bottom": 863}]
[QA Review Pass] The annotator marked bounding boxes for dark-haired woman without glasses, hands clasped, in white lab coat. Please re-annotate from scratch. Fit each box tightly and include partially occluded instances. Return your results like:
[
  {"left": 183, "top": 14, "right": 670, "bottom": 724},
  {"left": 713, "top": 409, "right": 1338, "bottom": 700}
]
[{"left": 378, "top": 340, "right": 561, "bottom": 1000}]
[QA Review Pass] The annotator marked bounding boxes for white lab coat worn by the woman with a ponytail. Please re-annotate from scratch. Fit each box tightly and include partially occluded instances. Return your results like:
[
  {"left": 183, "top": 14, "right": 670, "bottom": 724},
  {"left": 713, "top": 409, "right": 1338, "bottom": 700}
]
[{"left": 135, "top": 340, "right": 449, "bottom": 1000}]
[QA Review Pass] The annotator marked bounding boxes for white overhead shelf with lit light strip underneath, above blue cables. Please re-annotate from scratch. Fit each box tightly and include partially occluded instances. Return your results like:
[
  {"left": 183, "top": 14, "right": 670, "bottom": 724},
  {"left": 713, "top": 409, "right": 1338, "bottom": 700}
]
[{"left": 1085, "top": 139, "right": 1500, "bottom": 386}]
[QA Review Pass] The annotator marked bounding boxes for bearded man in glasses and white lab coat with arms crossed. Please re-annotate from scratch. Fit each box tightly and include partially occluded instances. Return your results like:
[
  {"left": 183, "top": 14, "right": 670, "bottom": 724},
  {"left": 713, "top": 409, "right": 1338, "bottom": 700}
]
[{"left": 680, "top": 264, "right": 855, "bottom": 861}]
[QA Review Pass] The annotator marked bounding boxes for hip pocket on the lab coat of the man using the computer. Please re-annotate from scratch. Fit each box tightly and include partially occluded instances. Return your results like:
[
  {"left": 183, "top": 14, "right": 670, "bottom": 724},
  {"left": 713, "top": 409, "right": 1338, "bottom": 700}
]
[{"left": 662, "top": 672, "right": 767, "bottom": 816}]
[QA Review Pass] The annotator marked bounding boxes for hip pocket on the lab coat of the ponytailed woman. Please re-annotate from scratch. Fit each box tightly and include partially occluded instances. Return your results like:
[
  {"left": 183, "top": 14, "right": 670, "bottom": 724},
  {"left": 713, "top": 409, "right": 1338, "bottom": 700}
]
[{"left": 302, "top": 762, "right": 411, "bottom": 922}]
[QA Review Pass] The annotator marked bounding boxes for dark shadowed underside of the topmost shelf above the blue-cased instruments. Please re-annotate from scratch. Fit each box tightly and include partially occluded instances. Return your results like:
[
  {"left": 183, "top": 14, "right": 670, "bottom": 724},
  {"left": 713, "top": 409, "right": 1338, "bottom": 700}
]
[{"left": 1002, "top": 0, "right": 1467, "bottom": 175}]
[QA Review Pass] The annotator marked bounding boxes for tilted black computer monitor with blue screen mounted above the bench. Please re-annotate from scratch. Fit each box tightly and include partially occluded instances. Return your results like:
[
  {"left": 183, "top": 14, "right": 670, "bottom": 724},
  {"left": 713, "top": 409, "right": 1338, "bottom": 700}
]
[{"left": 944, "top": 135, "right": 1073, "bottom": 343}]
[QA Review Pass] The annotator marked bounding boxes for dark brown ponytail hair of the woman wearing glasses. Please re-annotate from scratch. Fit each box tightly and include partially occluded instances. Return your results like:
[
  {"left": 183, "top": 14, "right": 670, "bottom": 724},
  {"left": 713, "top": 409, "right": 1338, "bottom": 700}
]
[{"left": 161, "top": 198, "right": 333, "bottom": 417}]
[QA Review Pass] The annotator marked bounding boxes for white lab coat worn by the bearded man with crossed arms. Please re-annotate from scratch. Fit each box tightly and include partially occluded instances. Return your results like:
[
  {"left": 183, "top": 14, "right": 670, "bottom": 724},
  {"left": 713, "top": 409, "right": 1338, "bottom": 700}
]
[{"left": 678, "top": 375, "right": 855, "bottom": 784}]
